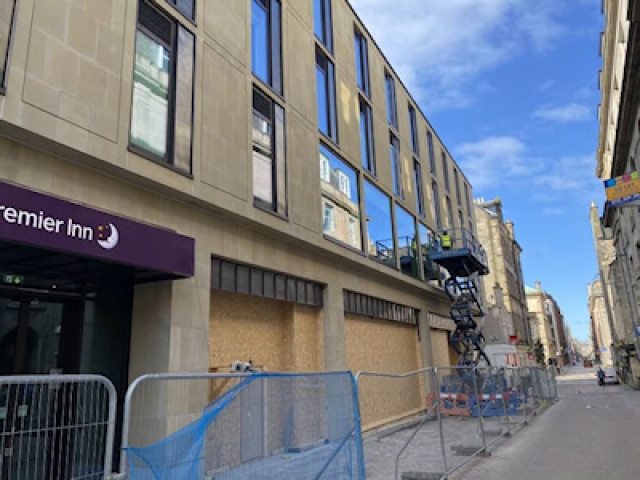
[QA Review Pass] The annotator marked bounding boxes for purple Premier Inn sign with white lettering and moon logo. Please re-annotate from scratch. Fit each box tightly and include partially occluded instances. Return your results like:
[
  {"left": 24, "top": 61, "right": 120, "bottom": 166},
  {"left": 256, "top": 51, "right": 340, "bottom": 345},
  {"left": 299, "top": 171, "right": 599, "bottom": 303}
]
[{"left": 0, "top": 182, "right": 195, "bottom": 277}]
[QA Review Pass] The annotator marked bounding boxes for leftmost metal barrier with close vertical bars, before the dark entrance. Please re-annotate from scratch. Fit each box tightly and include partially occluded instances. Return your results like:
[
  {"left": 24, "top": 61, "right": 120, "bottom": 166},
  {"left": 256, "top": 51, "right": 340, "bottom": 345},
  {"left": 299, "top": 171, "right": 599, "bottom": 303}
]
[{"left": 0, "top": 375, "right": 116, "bottom": 480}]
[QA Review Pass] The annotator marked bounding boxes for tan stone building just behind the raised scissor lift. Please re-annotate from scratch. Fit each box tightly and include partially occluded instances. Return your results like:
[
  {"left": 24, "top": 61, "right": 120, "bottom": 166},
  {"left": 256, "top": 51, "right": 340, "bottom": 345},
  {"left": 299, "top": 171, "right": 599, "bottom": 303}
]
[{"left": 475, "top": 198, "right": 531, "bottom": 365}]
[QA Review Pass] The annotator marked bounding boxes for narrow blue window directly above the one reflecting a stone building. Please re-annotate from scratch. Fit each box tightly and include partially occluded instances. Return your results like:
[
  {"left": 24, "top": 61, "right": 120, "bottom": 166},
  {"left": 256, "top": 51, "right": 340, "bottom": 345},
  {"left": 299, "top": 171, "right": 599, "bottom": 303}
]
[{"left": 316, "top": 48, "right": 338, "bottom": 143}]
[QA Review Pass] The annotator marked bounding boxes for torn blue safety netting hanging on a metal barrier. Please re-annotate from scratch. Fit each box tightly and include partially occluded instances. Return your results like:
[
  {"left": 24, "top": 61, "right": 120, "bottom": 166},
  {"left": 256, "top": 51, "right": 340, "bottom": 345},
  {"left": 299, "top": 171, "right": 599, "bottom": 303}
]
[{"left": 126, "top": 372, "right": 365, "bottom": 480}]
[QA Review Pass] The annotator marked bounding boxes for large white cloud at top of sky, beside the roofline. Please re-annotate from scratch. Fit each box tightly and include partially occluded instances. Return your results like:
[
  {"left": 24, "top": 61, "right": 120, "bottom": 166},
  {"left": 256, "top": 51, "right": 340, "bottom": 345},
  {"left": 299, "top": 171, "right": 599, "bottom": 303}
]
[{"left": 351, "top": 0, "right": 563, "bottom": 111}]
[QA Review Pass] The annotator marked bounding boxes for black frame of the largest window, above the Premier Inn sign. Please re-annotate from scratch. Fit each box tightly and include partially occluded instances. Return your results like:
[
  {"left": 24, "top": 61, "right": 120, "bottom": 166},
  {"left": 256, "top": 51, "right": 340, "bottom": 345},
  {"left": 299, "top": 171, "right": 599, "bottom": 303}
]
[{"left": 127, "top": 0, "right": 196, "bottom": 178}]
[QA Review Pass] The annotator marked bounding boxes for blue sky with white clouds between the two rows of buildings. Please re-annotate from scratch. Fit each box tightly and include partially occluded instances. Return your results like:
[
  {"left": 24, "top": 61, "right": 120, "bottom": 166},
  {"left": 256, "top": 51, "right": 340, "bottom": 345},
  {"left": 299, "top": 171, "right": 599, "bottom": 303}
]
[{"left": 350, "top": 0, "right": 605, "bottom": 341}]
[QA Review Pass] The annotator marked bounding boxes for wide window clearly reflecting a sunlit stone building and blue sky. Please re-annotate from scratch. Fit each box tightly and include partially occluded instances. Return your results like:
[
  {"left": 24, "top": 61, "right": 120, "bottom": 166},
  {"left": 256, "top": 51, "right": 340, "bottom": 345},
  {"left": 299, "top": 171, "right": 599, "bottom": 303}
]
[{"left": 320, "top": 145, "right": 362, "bottom": 250}]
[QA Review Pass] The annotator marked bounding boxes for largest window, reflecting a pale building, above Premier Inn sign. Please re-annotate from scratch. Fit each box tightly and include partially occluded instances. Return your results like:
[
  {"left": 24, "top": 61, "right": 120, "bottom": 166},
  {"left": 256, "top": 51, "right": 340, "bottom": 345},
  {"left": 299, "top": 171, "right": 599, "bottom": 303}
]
[{"left": 129, "top": 0, "right": 195, "bottom": 173}]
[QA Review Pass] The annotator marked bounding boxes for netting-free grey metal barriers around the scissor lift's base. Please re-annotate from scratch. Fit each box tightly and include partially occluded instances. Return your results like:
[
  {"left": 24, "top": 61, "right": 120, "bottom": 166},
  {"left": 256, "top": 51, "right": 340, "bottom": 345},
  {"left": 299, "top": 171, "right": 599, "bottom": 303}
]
[{"left": 356, "top": 367, "right": 556, "bottom": 480}]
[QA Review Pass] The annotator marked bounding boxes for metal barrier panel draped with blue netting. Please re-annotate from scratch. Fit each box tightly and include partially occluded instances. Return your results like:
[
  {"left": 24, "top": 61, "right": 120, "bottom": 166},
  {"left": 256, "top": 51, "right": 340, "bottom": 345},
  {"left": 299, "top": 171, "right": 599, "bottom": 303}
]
[{"left": 120, "top": 372, "right": 364, "bottom": 480}]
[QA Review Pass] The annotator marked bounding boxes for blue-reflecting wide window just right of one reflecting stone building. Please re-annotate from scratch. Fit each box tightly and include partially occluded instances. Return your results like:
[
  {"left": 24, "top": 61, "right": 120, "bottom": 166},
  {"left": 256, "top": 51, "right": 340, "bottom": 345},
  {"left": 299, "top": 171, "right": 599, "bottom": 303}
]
[{"left": 364, "top": 180, "right": 396, "bottom": 268}]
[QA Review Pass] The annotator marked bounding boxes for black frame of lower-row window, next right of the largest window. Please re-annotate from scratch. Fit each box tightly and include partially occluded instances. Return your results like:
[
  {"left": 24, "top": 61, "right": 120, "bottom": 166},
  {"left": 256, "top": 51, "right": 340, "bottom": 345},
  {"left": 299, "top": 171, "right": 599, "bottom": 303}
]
[{"left": 251, "top": 84, "right": 289, "bottom": 218}]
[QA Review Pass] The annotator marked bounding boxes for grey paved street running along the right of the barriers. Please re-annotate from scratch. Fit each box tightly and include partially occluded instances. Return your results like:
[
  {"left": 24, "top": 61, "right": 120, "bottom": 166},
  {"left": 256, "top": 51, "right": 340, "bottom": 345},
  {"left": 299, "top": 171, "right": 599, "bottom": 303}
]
[{"left": 449, "top": 367, "right": 640, "bottom": 480}]
